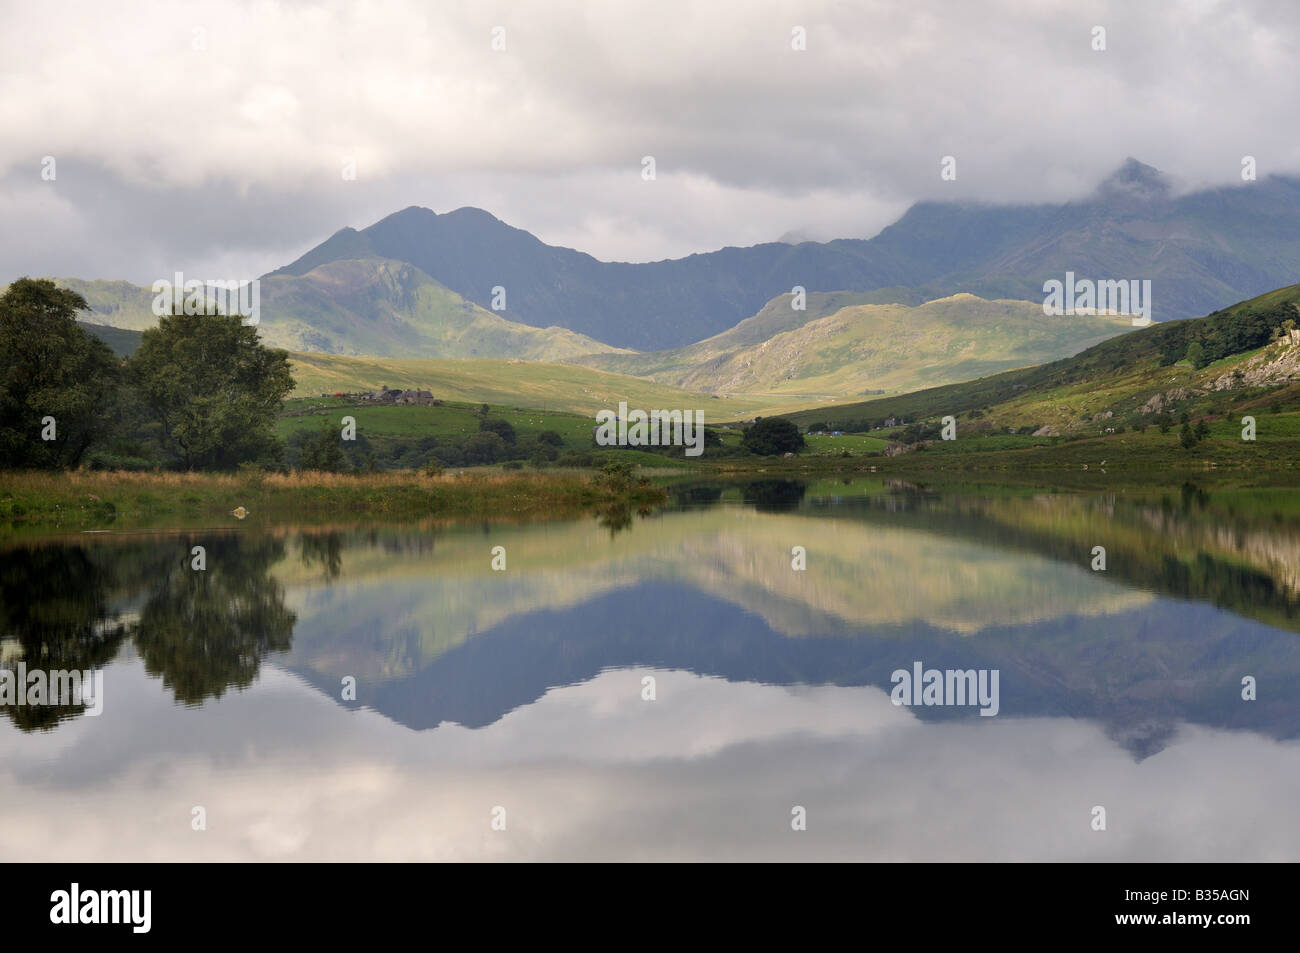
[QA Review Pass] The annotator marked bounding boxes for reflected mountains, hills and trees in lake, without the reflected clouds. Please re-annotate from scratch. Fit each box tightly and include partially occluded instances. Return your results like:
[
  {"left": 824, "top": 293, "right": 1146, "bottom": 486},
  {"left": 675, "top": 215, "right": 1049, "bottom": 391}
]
[{"left": 0, "top": 478, "right": 1300, "bottom": 759}]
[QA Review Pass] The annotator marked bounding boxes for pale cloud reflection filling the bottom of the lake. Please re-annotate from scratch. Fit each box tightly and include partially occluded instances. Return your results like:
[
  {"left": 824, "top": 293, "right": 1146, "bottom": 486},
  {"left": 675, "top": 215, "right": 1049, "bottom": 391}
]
[{"left": 0, "top": 659, "right": 1300, "bottom": 862}]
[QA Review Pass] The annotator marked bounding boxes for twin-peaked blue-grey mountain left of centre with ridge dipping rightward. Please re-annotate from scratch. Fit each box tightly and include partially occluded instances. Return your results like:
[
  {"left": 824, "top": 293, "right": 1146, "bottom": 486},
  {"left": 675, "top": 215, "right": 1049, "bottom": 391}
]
[{"left": 268, "top": 207, "right": 923, "bottom": 348}]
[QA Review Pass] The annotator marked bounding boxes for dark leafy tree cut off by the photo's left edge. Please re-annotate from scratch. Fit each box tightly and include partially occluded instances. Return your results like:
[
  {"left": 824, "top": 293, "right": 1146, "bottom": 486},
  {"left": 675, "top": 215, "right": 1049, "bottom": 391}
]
[{"left": 0, "top": 278, "right": 121, "bottom": 469}]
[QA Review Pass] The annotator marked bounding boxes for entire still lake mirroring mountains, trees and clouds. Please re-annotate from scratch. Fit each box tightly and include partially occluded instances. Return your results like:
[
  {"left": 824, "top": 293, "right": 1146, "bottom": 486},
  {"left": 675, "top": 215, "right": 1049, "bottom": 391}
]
[{"left": 0, "top": 480, "right": 1300, "bottom": 861}]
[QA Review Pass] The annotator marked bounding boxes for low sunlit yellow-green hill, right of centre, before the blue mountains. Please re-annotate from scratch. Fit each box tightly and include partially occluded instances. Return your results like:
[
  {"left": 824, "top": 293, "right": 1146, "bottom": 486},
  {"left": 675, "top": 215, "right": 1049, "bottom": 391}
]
[{"left": 577, "top": 293, "right": 1131, "bottom": 397}]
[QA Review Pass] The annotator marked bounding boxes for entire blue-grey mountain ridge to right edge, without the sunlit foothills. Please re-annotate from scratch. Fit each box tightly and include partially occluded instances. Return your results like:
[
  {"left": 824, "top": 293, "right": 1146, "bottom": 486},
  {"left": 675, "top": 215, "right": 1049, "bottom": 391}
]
[{"left": 268, "top": 159, "right": 1300, "bottom": 350}]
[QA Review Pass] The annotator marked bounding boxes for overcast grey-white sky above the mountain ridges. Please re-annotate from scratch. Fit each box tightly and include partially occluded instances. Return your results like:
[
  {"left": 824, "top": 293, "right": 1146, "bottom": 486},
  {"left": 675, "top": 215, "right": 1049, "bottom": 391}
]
[{"left": 0, "top": 0, "right": 1300, "bottom": 283}]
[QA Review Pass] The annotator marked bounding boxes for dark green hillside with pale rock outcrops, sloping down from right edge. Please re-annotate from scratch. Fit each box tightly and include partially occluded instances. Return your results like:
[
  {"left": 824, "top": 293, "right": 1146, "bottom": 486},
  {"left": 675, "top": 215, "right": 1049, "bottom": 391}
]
[{"left": 787, "top": 285, "right": 1300, "bottom": 464}]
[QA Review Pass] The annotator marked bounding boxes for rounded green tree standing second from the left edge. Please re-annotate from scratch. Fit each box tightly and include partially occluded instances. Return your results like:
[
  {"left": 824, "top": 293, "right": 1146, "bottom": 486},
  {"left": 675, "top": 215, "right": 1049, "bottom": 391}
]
[{"left": 129, "top": 315, "right": 294, "bottom": 469}]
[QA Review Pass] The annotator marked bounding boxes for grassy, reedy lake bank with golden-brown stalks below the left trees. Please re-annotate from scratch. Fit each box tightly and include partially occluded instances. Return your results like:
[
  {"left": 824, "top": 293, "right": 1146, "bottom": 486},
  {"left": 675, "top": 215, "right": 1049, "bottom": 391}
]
[{"left": 0, "top": 471, "right": 667, "bottom": 536}]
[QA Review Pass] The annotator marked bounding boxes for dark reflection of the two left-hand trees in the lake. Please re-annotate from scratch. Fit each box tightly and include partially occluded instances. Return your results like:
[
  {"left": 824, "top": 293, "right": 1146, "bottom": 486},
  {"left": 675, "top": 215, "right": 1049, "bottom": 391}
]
[{"left": 0, "top": 536, "right": 295, "bottom": 731}]
